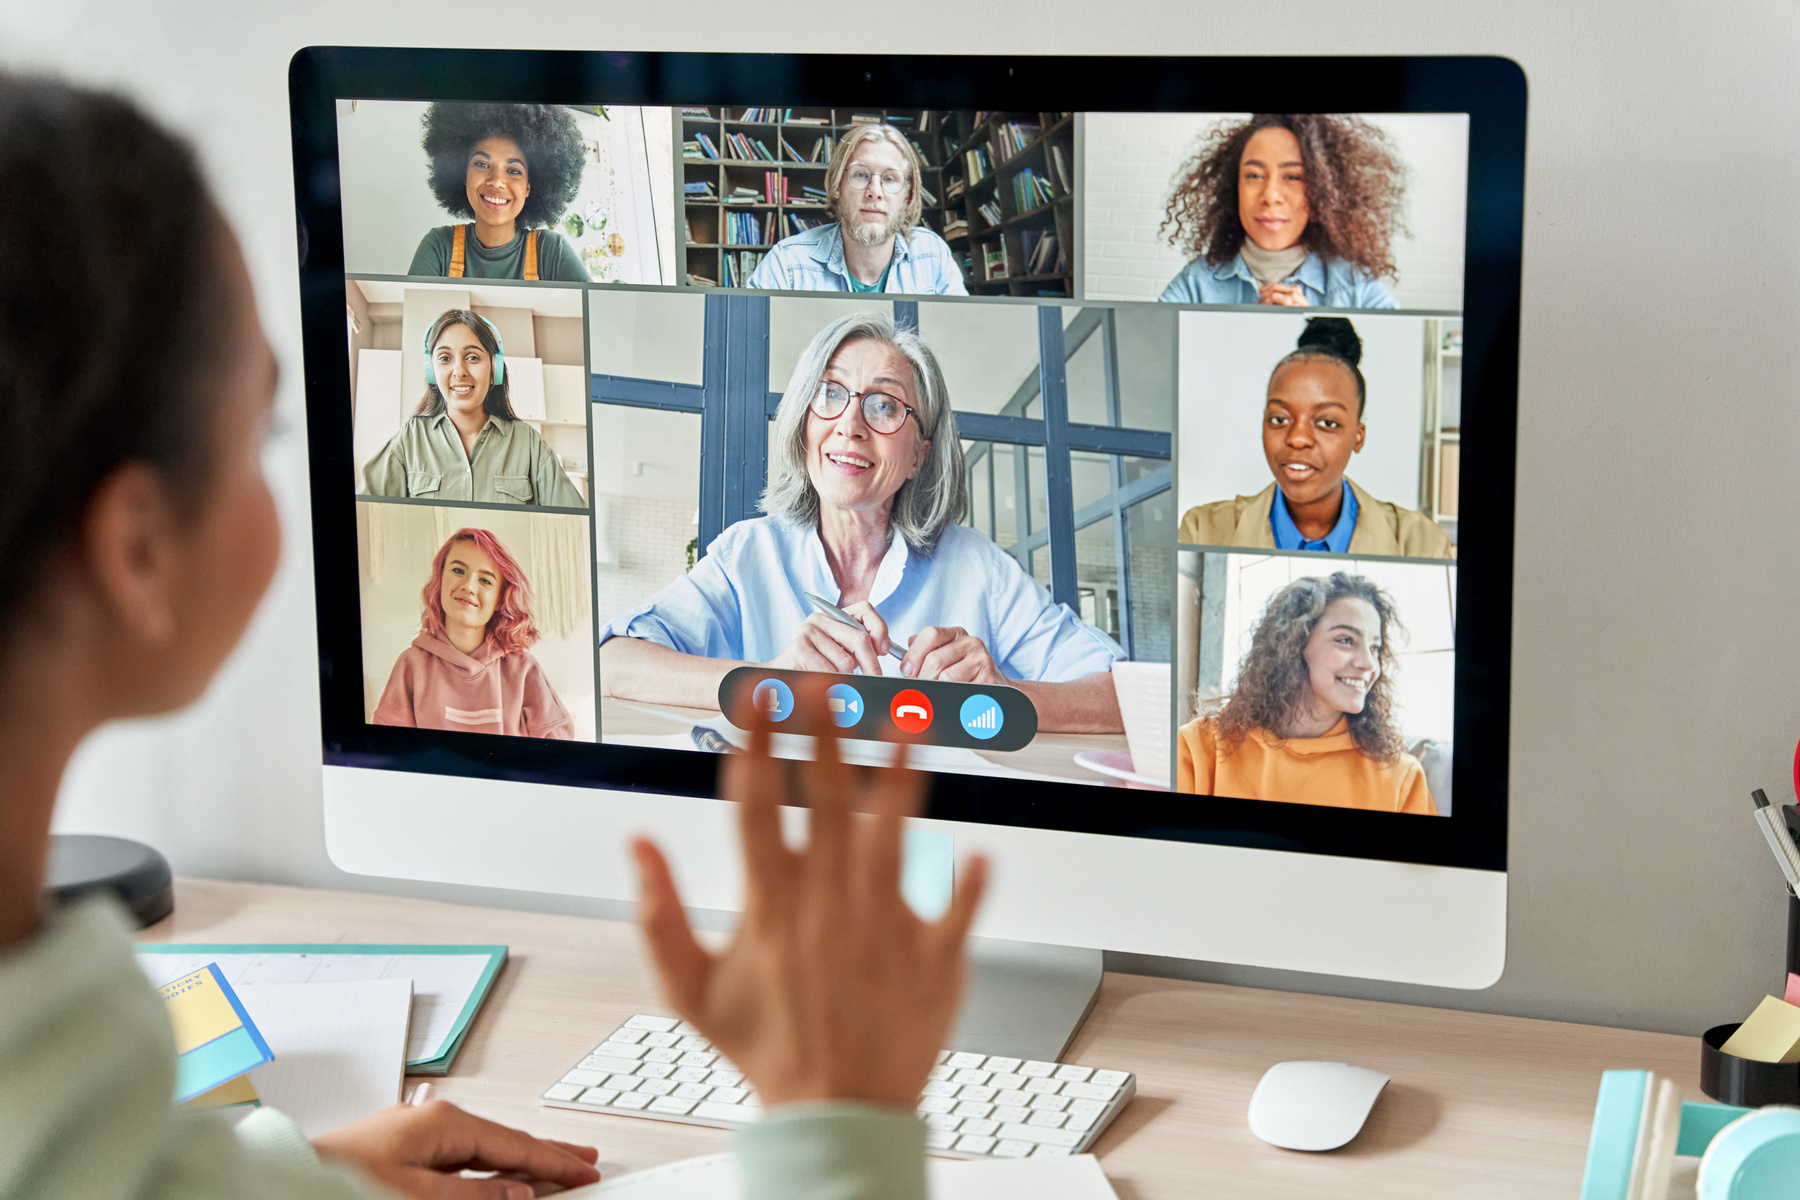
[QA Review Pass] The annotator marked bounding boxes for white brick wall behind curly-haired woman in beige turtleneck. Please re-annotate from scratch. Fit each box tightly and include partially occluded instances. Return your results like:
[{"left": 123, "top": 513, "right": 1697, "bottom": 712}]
[{"left": 1082, "top": 113, "right": 1469, "bottom": 309}]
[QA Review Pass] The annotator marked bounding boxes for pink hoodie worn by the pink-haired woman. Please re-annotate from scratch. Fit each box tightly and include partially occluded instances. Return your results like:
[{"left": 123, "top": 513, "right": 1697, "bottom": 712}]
[{"left": 374, "top": 633, "right": 574, "bottom": 739}]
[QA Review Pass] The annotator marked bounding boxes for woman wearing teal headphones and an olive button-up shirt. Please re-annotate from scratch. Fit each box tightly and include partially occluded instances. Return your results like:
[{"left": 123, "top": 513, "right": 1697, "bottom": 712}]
[{"left": 362, "top": 308, "right": 587, "bottom": 509}]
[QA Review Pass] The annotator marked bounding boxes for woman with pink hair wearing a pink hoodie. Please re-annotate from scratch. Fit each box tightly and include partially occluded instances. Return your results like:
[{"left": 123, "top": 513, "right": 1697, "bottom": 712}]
[{"left": 374, "top": 529, "right": 574, "bottom": 739}]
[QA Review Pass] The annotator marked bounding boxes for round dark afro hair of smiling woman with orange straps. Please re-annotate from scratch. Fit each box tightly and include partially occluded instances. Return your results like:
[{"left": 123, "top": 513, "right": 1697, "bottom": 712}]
[{"left": 419, "top": 101, "right": 587, "bottom": 228}]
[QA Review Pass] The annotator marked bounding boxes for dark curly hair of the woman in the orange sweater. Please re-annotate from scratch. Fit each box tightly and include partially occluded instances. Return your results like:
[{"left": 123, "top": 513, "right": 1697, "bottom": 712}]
[{"left": 1211, "top": 570, "right": 1404, "bottom": 763}]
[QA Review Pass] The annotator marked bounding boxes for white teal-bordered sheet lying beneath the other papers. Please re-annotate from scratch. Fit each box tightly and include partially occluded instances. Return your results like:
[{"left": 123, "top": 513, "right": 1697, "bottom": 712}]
[{"left": 137, "top": 954, "right": 488, "bottom": 1061}]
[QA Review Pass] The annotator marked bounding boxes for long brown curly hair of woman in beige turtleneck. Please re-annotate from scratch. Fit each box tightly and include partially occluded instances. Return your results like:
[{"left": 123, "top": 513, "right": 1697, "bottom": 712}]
[{"left": 1157, "top": 113, "right": 1406, "bottom": 279}]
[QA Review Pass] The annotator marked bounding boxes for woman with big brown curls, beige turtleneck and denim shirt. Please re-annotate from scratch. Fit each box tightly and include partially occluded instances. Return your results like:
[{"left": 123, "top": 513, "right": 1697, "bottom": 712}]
[{"left": 1161, "top": 113, "right": 1406, "bottom": 308}]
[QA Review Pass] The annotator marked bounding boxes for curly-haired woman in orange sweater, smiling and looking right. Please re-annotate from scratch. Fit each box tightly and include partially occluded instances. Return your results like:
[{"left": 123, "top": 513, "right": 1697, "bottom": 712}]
[{"left": 1175, "top": 570, "right": 1438, "bottom": 817}]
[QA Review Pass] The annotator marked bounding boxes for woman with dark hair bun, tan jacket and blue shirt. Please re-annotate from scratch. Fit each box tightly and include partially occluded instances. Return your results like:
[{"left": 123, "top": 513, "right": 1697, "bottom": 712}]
[{"left": 1177, "top": 317, "right": 1456, "bottom": 558}]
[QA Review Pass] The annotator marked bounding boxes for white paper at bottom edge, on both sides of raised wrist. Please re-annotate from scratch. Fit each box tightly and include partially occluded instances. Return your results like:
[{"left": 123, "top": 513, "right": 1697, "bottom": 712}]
[{"left": 563, "top": 1153, "right": 1118, "bottom": 1200}]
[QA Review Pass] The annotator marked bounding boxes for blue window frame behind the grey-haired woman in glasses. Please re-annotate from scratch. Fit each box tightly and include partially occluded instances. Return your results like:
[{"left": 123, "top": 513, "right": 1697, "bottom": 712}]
[{"left": 590, "top": 293, "right": 1174, "bottom": 657}]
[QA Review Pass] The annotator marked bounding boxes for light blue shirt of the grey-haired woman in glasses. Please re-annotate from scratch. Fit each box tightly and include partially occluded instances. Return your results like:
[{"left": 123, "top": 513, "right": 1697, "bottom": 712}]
[{"left": 599, "top": 516, "right": 1125, "bottom": 684}]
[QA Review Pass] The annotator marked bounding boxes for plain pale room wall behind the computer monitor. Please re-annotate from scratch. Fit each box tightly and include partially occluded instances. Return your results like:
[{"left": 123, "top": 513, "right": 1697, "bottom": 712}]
[{"left": 21, "top": 0, "right": 1800, "bottom": 1034}]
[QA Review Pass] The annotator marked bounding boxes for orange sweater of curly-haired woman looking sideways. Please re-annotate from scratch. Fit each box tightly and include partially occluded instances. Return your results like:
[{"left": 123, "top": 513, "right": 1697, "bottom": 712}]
[{"left": 1175, "top": 718, "right": 1438, "bottom": 817}]
